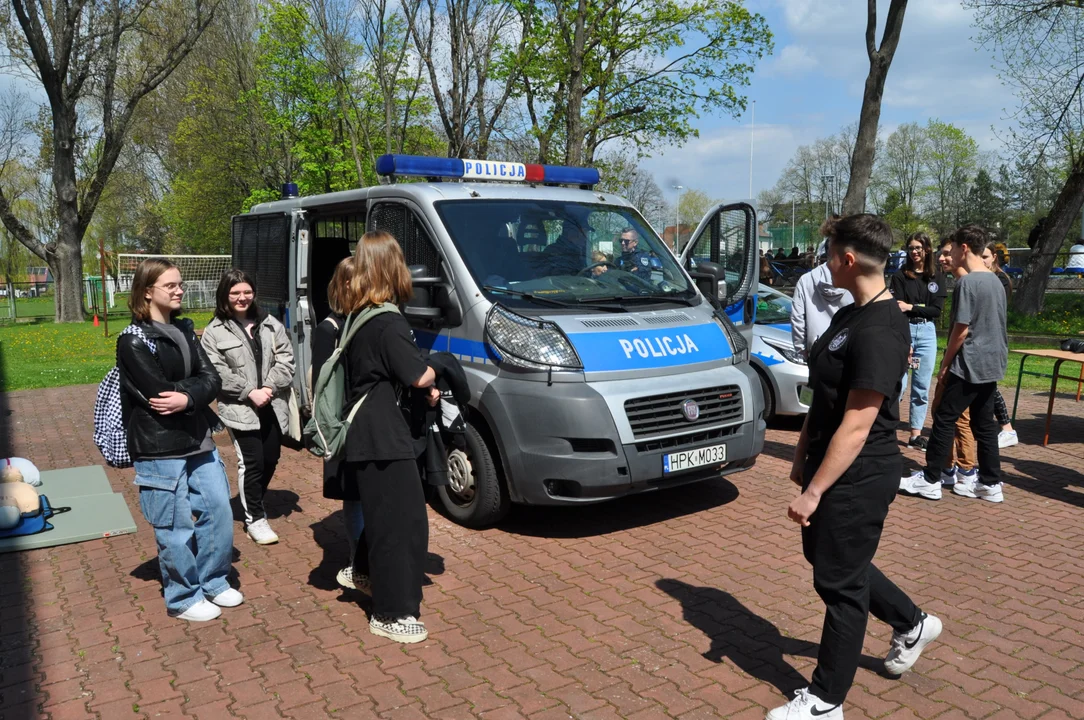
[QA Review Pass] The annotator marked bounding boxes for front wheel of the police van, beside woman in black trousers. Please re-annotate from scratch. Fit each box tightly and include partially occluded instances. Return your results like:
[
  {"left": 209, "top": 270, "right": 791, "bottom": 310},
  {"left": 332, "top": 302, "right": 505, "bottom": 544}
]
[{"left": 437, "top": 423, "right": 512, "bottom": 527}]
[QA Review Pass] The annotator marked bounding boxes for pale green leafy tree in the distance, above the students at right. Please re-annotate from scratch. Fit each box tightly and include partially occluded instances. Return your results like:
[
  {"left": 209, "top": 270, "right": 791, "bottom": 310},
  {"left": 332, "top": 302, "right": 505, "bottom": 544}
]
[{"left": 922, "top": 119, "right": 979, "bottom": 234}]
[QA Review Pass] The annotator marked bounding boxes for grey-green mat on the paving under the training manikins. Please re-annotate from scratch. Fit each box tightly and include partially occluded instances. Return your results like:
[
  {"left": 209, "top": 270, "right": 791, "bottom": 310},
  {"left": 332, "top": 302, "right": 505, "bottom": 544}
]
[{"left": 0, "top": 465, "right": 136, "bottom": 553}]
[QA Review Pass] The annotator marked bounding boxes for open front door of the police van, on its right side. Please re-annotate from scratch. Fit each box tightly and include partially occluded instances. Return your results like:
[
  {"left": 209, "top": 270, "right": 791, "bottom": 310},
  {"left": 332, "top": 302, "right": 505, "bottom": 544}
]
[{"left": 680, "top": 203, "right": 758, "bottom": 327}]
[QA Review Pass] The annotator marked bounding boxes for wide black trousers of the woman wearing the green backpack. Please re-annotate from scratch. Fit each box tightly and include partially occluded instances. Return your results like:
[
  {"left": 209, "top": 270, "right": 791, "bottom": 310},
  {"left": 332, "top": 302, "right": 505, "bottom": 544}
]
[{"left": 344, "top": 460, "right": 429, "bottom": 617}]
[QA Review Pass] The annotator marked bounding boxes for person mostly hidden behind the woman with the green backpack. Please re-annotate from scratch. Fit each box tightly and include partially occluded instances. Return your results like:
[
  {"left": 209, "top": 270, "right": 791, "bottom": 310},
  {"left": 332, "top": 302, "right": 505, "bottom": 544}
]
[{"left": 308, "top": 257, "right": 370, "bottom": 592}]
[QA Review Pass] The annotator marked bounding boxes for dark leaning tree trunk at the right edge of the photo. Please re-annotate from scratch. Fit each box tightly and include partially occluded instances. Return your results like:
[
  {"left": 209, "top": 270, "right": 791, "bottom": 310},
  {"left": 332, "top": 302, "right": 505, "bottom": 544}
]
[{"left": 1012, "top": 156, "right": 1084, "bottom": 316}]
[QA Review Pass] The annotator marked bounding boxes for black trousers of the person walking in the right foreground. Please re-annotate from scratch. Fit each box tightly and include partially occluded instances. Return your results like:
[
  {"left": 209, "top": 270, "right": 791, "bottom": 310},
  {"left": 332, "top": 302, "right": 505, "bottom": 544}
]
[{"left": 802, "top": 454, "right": 921, "bottom": 705}]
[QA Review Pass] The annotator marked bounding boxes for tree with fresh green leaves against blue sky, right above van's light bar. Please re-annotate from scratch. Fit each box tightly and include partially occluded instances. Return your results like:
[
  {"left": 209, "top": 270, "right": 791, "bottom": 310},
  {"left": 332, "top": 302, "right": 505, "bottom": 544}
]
[{"left": 504, "top": 0, "right": 772, "bottom": 165}]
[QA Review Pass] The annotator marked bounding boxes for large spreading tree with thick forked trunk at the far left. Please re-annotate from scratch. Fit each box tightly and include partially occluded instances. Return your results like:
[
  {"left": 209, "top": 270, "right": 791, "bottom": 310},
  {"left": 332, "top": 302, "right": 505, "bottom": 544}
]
[{"left": 0, "top": 0, "right": 217, "bottom": 322}]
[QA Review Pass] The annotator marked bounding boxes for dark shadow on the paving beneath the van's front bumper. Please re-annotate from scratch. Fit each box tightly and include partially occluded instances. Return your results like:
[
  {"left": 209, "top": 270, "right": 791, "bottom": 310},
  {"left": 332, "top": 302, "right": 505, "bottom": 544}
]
[{"left": 496, "top": 478, "right": 738, "bottom": 538}]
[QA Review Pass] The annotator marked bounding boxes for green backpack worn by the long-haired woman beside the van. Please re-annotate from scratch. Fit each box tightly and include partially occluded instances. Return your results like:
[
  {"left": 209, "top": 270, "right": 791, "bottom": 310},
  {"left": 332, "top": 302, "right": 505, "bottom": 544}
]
[{"left": 301, "top": 304, "right": 399, "bottom": 460}]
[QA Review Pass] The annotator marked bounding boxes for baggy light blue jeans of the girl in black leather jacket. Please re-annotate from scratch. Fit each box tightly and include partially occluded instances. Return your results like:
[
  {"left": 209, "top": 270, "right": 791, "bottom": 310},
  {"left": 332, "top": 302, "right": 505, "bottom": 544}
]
[{"left": 134, "top": 450, "right": 233, "bottom": 615}]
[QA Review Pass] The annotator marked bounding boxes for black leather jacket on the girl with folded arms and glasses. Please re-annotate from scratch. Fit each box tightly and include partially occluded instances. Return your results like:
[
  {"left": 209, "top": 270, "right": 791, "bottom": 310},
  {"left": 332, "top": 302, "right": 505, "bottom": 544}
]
[{"left": 117, "top": 320, "right": 222, "bottom": 460}]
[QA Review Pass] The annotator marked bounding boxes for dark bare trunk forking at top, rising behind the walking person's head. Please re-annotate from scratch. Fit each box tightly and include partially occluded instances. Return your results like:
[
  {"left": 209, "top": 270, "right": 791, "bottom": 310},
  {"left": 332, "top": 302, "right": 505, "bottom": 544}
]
[{"left": 843, "top": 0, "right": 907, "bottom": 215}]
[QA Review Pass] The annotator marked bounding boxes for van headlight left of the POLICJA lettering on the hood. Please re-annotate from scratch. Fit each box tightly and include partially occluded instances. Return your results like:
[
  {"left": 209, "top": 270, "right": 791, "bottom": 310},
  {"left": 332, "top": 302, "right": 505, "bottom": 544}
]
[{"left": 486, "top": 305, "right": 583, "bottom": 370}]
